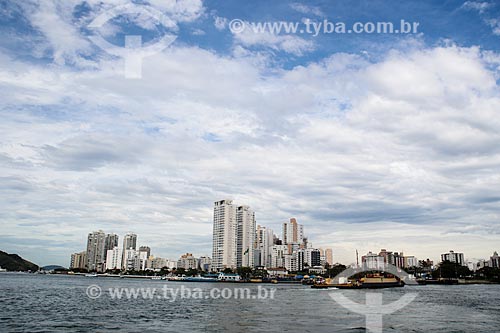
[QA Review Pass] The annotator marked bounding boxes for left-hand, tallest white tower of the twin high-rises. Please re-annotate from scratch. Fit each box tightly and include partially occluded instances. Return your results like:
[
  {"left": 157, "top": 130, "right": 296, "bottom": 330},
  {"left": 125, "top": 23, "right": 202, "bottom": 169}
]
[{"left": 212, "top": 200, "right": 238, "bottom": 270}]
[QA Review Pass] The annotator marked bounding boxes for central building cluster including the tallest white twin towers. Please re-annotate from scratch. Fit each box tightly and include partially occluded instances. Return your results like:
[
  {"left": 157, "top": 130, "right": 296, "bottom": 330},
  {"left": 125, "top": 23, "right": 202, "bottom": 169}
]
[{"left": 212, "top": 199, "right": 333, "bottom": 273}]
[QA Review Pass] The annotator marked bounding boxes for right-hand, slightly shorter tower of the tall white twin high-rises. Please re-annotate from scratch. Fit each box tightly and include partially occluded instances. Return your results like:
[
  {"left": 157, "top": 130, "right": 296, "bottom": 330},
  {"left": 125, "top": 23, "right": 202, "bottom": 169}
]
[{"left": 236, "top": 206, "right": 255, "bottom": 268}]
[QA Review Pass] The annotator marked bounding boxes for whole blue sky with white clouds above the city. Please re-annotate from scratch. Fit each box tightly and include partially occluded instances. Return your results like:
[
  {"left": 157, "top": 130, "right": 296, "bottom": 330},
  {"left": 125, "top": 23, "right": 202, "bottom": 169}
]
[{"left": 0, "top": 0, "right": 500, "bottom": 266}]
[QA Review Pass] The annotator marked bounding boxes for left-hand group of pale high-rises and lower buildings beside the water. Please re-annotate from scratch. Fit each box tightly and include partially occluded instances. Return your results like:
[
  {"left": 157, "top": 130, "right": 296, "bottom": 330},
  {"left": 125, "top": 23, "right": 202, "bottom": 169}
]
[{"left": 70, "top": 230, "right": 211, "bottom": 272}]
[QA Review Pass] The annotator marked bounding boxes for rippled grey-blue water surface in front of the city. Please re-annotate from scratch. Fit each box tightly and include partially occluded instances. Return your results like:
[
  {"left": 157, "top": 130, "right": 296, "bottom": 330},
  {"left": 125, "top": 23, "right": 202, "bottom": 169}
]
[{"left": 0, "top": 273, "right": 500, "bottom": 332}]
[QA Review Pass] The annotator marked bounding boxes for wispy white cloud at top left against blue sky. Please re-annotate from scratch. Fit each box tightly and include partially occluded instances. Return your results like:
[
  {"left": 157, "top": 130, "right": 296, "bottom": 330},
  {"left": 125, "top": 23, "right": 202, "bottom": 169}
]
[{"left": 15, "top": 0, "right": 204, "bottom": 67}]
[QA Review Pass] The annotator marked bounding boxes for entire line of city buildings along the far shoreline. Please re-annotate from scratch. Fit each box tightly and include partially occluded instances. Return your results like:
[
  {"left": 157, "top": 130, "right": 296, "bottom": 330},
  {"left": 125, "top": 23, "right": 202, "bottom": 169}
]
[{"left": 70, "top": 199, "right": 500, "bottom": 274}]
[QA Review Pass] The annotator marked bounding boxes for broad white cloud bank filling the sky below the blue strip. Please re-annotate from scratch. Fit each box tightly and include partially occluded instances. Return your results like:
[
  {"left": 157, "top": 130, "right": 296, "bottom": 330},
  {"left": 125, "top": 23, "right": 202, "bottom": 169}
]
[{"left": 0, "top": 22, "right": 500, "bottom": 264}]
